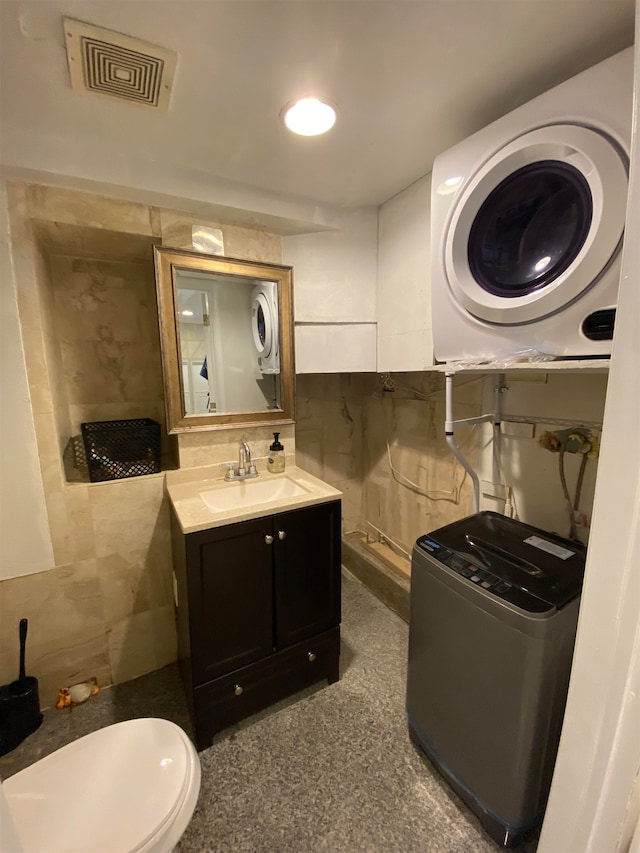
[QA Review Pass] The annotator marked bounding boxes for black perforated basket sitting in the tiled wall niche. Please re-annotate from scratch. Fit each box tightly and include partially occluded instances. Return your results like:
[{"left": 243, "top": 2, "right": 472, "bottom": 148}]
[{"left": 80, "top": 418, "right": 161, "bottom": 483}]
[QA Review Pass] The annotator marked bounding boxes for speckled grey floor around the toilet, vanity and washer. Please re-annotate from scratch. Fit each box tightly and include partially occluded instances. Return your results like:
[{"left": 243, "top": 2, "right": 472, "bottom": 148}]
[{"left": 0, "top": 577, "right": 535, "bottom": 853}]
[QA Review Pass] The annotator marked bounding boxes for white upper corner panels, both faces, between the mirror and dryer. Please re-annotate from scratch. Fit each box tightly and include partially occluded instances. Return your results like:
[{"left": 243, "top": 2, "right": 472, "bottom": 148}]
[{"left": 282, "top": 180, "right": 434, "bottom": 373}]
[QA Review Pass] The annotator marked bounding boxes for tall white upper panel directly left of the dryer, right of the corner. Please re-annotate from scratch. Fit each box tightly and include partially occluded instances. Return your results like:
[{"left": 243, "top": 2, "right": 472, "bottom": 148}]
[{"left": 378, "top": 174, "right": 433, "bottom": 371}]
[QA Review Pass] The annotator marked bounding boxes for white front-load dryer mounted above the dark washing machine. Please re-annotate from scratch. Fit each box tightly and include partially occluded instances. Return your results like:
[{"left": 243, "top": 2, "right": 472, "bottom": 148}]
[{"left": 431, "top": 48, "right": 633, "bottom": 362}]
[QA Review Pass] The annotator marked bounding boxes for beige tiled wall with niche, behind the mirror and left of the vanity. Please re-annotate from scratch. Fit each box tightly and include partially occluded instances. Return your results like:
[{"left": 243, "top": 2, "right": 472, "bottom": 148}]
[{"left": 0, "top": 184, "right": 288, "bottom": 707}]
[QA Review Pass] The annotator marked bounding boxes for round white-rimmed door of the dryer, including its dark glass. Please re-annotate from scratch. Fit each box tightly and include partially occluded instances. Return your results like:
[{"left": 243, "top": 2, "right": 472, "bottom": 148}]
[{"left": 444, "top": 125, "right": 628, "bottom": 325}]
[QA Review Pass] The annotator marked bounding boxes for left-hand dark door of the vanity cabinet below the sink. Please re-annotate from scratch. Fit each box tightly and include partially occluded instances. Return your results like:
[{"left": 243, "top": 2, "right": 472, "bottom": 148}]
[{"left": 187, "top": 517, "right": 274, "bottom": 685}]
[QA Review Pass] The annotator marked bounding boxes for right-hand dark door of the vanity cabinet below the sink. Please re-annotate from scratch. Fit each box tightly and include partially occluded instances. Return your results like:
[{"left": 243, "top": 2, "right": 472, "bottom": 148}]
[{"left": 273, "top": 501, "right": 340, "bottom": 649}]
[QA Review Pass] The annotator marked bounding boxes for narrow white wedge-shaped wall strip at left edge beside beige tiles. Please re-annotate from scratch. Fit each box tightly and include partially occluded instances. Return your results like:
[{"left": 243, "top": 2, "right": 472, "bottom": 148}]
[{"left": 0, "top": 183, "right": 54, "bottom": 580}]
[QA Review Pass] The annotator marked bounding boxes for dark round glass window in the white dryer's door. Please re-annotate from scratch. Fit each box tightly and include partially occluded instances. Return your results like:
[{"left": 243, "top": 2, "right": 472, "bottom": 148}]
[{"left": 468, "top": 160, "right": 593, "bottom": 298}]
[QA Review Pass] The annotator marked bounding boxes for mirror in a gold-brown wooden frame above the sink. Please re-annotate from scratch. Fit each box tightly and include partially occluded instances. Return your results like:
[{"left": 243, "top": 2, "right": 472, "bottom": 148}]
[{"left": 154, "top": 246, "right": 295, "bottom": 434}]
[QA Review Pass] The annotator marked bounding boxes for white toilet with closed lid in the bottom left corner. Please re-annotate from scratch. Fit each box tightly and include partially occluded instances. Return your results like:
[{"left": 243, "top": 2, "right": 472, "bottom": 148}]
[{"left": 0, "top": 719, "right": 200, "bottom": 853}]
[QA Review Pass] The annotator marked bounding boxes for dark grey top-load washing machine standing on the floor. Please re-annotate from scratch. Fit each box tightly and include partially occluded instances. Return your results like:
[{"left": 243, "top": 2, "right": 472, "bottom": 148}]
[{"left": 407, "top": 512, "right": 586, "bottom": 847}]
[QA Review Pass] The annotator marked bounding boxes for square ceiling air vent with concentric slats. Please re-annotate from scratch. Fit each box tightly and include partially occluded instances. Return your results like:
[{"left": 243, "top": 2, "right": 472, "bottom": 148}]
[{"left": 64, "top": 18, "right": 177, "bottom": 112}]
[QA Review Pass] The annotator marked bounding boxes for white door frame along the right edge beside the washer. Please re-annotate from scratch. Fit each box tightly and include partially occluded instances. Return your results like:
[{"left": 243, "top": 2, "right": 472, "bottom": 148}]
[{"left": 538, "top": 8, "right": 640, "bottom": 853}]
